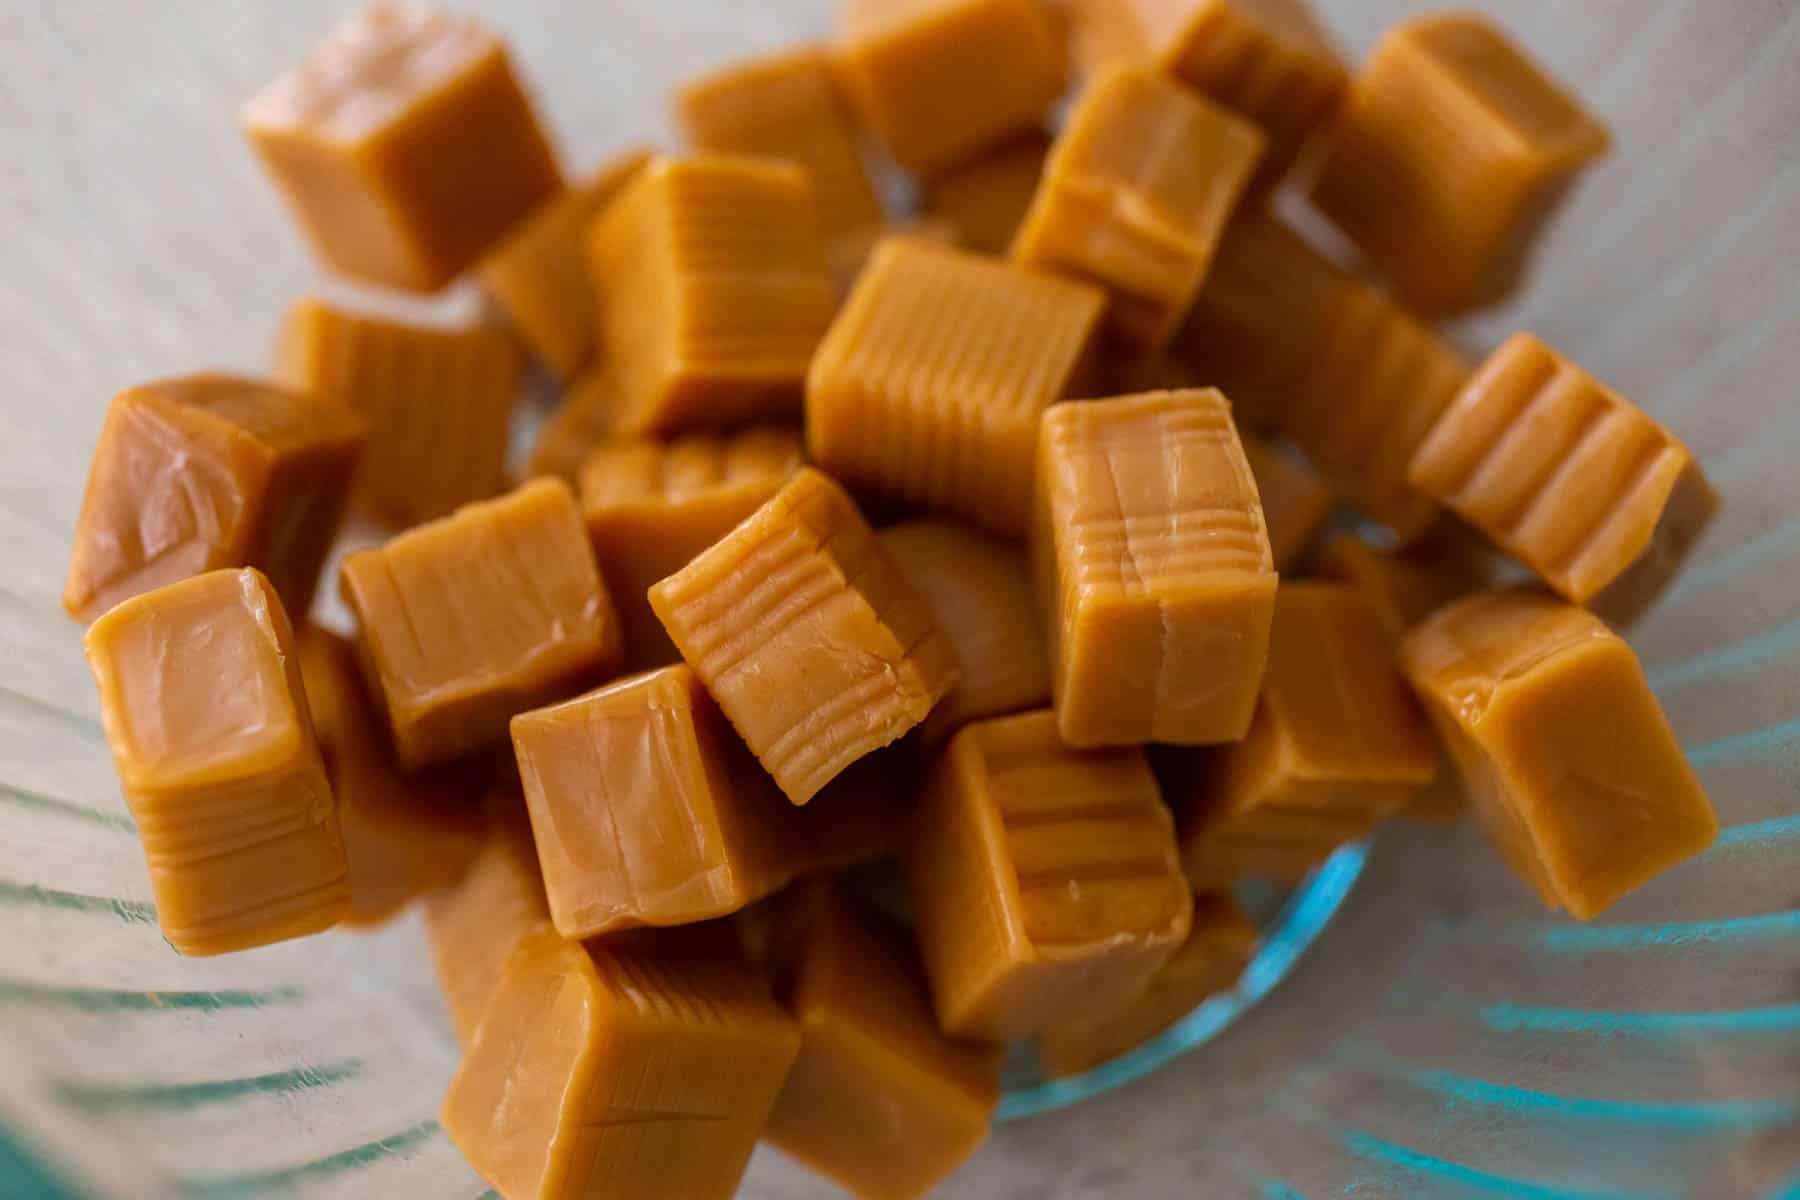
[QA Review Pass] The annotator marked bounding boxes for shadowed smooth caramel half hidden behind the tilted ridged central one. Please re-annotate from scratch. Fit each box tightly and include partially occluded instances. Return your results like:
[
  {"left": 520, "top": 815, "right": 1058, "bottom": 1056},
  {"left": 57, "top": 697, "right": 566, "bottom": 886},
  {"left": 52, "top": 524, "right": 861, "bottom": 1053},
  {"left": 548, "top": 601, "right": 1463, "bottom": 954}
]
[{"left": 877, "top": 520, "right": 1049, "bottom": 747}]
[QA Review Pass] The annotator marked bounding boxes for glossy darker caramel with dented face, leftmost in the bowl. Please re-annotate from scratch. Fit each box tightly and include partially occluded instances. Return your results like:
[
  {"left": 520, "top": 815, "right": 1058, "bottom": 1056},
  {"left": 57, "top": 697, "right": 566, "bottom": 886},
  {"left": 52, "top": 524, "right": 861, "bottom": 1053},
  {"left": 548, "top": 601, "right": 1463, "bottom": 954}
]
[{"left": 63, "top": 374, "right": 365, "bottom": 622}]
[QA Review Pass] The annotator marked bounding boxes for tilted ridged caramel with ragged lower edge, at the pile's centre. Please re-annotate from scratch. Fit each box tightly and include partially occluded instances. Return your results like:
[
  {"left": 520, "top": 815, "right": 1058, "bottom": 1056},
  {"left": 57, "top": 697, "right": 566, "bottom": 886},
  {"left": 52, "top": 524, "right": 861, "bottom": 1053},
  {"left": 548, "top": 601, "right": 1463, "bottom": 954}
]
[{"left": 650, "top": 470, "right": 958, "bottom": 804}]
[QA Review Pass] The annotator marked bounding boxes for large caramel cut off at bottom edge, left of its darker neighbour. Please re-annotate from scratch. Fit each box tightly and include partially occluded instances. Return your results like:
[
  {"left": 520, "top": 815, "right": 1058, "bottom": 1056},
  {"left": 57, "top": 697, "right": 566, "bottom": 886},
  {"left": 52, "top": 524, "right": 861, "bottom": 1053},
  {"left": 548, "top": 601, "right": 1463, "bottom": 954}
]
[{"left": 439, "top": 927, "right": 799, "bottom": 1200}]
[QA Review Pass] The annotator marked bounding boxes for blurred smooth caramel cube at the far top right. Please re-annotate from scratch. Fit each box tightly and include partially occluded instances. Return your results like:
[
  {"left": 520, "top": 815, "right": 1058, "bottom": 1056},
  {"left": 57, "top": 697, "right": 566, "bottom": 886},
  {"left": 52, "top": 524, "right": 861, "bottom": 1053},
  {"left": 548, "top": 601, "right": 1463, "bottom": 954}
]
[{"left": 1312, "top": 13, "right": 1609, "bottom": 311}]
